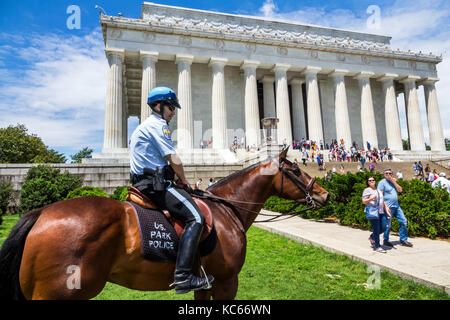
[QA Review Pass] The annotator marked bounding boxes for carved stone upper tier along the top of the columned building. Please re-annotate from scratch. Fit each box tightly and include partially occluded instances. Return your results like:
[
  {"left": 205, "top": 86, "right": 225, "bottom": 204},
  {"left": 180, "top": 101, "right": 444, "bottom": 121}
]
[{"left": 100, "top": 3, "right": 442, "bottom": 61}]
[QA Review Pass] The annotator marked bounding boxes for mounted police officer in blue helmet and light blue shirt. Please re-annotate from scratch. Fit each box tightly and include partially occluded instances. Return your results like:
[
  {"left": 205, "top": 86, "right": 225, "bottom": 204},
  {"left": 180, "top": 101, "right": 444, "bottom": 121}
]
[{"left": 130, "top": 87, "right": 213, "bottom": 293}]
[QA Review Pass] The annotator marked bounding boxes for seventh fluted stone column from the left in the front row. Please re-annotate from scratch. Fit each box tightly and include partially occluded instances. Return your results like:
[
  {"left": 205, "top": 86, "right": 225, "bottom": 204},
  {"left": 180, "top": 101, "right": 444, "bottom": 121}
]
[{"left": 305, "top": 67, "right": 323, "bottom": 145}]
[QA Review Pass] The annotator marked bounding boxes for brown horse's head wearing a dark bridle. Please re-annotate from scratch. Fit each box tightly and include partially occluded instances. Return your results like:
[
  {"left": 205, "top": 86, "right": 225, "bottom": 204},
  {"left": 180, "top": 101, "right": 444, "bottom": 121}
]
[{"left": 272, "top": 147, "right": 329, "bottom": 207}]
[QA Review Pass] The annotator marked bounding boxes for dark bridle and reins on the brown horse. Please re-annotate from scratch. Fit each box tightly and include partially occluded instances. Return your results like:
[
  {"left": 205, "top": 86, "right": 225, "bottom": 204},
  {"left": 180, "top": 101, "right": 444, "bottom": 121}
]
[{"left": 193, "top": 158, "right": 318, "bottom": 223}]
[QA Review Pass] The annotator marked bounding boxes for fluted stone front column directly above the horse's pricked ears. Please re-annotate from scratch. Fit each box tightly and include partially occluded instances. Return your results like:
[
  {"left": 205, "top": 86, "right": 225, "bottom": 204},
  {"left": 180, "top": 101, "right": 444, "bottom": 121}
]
[{"left": 274, "top": 63, "right": 292, "bottom": 146}]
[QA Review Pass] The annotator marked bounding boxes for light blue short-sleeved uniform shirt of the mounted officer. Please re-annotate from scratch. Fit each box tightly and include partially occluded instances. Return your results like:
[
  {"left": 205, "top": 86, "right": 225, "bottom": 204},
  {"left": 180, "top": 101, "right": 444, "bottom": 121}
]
[{"left": 130, "top": 114, "right": 176, "bottom": 175}]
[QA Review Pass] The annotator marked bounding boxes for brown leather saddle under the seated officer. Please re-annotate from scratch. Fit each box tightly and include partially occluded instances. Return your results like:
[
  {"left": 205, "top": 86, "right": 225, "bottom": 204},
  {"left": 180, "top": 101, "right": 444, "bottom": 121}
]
[{"left": 126, "top": 186, "right": 213, "bottom": 242}]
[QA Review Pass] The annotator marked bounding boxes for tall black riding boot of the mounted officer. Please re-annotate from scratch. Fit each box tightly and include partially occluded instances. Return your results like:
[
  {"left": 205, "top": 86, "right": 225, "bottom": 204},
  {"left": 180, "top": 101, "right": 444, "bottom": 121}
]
[{"left": 174, "top": 222, "right": 214, "bottom": 293}]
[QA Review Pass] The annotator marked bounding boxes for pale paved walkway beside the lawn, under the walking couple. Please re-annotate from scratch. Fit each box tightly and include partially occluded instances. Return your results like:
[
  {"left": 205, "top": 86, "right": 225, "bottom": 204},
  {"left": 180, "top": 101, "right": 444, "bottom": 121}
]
[{"left": 254, "top": 210, "right": 450, "bottom": 295}]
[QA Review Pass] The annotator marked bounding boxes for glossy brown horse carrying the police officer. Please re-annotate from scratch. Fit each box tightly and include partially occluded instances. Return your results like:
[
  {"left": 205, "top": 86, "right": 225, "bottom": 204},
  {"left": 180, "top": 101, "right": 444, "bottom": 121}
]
[{"left": 0, "top": 149, "right": 328, "bottom": 299}]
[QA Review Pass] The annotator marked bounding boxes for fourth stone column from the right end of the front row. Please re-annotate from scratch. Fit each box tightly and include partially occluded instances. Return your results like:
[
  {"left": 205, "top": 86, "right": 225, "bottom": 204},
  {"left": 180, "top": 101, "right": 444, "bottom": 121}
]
[{"left": 355, "top": 71, "right": 378, "bottom": 150}]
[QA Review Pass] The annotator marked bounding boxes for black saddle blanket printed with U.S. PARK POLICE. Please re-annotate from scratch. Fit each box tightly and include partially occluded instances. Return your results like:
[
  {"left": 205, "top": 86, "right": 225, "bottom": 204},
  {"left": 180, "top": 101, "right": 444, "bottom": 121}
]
[{"left": 127, "top": 201, "right": 217, "bottom": 262}]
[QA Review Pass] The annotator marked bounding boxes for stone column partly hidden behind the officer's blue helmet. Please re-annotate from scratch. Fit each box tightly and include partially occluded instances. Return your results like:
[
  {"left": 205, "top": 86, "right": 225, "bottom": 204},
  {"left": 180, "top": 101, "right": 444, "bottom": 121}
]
[{"left": 139, "top": 51, "right": 159, "bottom": 122}]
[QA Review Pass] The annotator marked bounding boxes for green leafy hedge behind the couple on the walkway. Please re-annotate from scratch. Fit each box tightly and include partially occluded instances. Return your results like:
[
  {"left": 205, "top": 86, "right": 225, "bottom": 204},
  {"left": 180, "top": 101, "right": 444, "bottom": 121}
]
[{"left": 265, "top": 172, "right": 450, "bottom": 238}]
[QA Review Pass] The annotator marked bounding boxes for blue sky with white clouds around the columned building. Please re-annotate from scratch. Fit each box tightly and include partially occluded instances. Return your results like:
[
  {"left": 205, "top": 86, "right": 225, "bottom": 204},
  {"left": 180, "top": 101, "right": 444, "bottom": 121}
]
[{"left": 0, "top": 0, "right": 450, "bottom": 159}]
